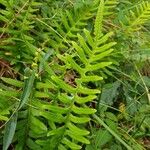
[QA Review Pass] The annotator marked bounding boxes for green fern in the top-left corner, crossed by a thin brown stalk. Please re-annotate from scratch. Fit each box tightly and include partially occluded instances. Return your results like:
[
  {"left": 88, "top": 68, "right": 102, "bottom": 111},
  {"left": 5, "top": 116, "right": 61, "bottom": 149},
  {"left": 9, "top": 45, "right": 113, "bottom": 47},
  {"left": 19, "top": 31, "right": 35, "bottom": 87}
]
[{"left": 0, "top": 0, "right": 41, "bottom": 70}]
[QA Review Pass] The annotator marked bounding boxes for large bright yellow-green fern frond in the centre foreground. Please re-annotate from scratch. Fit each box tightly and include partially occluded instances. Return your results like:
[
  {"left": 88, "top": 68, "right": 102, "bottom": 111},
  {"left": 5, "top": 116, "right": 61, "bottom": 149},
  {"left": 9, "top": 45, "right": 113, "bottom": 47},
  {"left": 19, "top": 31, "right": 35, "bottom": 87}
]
[{"left": 31, "top": 0, "right": 115, "bottom": 149}]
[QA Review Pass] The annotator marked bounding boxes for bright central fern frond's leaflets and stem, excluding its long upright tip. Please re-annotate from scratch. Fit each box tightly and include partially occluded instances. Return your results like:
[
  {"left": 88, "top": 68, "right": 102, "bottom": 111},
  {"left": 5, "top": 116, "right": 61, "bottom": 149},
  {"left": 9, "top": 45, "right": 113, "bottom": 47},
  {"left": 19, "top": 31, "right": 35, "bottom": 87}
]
[{"left": 46, "top": 30, "right": 114, "bottom": 149}]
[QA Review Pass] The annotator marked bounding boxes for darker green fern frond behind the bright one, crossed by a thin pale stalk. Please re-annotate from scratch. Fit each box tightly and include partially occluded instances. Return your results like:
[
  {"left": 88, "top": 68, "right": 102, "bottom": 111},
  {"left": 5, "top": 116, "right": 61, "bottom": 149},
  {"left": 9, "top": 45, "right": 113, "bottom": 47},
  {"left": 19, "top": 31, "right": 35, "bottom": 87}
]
[{"left": 36, "top": 2, "right": 92, "bottom": 52}]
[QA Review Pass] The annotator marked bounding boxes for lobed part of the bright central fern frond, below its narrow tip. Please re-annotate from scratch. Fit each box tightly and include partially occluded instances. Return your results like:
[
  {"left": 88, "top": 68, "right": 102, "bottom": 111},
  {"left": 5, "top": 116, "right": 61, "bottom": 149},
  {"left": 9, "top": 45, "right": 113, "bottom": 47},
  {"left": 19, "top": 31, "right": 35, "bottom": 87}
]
[{"left": 41, "top": 29, "right": 115, "bottom": 149}]
